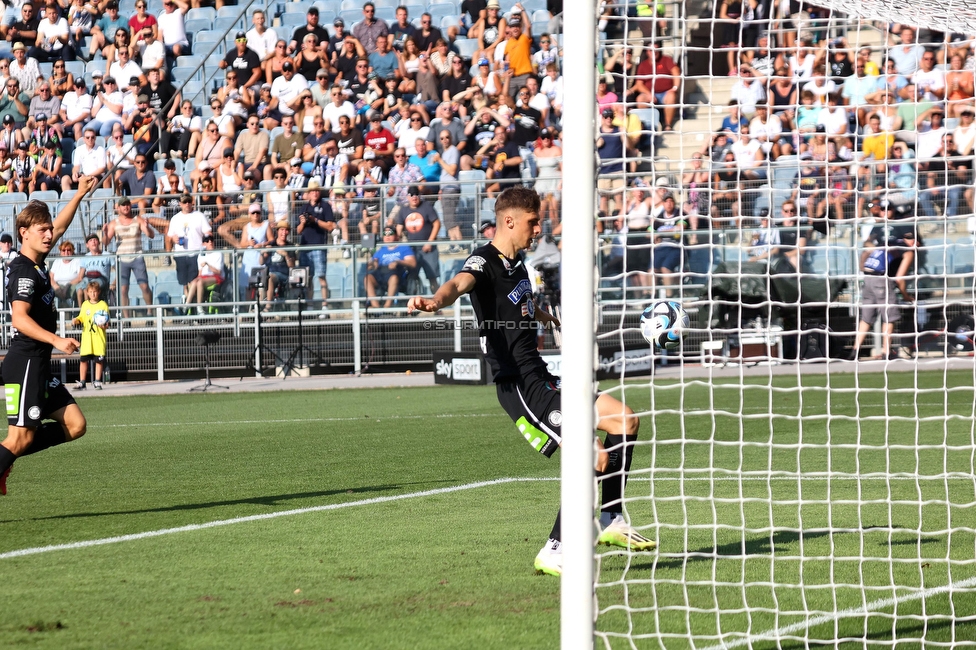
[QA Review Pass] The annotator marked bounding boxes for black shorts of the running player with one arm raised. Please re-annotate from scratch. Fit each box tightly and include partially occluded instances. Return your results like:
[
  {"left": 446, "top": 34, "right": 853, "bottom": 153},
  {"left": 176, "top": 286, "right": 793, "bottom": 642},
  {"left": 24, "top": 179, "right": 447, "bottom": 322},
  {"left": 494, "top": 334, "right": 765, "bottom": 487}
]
[{"left": 0, "top": 353, "right": 75, "bottom": 429}]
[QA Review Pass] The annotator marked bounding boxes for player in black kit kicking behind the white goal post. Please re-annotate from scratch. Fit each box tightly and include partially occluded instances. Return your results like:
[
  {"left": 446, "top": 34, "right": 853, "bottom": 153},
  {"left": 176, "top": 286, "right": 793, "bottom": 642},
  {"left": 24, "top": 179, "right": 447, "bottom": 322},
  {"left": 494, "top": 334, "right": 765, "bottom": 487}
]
[{"left": 407, "top": 187, "right": 657, "bottom": 576}]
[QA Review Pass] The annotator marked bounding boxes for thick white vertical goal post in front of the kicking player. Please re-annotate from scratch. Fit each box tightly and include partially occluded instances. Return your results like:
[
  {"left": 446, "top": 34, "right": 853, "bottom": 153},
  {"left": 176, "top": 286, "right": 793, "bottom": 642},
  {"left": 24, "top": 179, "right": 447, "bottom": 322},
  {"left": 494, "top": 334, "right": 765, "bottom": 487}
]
[{"left": 560, "top": 2, "right": 596, "bottom": 648}]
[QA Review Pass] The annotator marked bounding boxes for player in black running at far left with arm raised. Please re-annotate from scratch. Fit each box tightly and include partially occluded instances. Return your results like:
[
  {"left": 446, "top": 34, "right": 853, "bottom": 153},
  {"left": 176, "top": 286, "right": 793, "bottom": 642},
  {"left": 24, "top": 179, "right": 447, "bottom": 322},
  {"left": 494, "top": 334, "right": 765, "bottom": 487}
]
[{"left": 0, "top": 176, "right": 97, "bottom": 494}]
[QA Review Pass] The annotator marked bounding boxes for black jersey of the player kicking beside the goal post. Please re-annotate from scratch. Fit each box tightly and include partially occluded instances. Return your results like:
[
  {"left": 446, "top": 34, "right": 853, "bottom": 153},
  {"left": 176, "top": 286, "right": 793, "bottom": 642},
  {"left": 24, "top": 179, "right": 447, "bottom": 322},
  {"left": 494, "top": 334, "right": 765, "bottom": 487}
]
[{"left": 461, "top": 244, "right": 546, "bottom": 382}]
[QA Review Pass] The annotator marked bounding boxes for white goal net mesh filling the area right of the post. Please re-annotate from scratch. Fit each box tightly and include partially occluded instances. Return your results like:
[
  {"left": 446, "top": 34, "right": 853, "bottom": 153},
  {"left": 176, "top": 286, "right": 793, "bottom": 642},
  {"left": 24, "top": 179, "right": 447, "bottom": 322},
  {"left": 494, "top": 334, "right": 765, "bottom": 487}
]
[{"left": 588, "top": 0, "right": 976, "bottom": 649}]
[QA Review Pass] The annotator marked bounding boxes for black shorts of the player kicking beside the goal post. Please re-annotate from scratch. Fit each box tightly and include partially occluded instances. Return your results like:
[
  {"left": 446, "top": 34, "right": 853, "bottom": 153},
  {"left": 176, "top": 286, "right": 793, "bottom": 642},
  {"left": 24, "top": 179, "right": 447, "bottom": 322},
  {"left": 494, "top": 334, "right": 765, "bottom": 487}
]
[{"left": 496, "top": 372, "right": 563, "bottom": 458}]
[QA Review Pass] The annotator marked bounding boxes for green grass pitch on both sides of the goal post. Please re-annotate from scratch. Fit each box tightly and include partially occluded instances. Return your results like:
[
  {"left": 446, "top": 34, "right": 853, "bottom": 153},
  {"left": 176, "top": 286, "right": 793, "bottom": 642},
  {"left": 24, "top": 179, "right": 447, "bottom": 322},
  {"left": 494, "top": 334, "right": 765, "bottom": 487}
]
[{"left": 0, "top": 373, "right": 976, "bottom": 649}]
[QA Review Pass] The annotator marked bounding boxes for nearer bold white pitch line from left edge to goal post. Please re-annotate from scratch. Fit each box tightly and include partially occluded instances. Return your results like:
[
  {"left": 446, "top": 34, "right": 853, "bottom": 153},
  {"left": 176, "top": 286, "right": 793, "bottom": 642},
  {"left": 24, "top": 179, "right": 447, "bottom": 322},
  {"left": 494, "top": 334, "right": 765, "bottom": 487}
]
[{"left": 0, "top": 477, "right": 559, "bottom": 560}]
